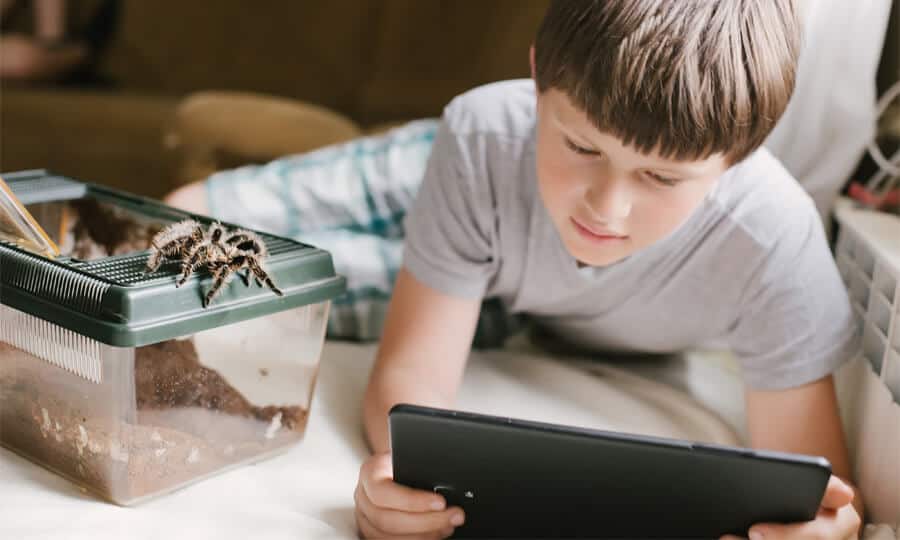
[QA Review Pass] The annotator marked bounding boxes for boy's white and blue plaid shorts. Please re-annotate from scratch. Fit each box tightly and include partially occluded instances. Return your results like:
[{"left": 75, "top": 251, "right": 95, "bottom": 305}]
[{"left": 205, "top": 119, "right": 519, "bottom": 347}]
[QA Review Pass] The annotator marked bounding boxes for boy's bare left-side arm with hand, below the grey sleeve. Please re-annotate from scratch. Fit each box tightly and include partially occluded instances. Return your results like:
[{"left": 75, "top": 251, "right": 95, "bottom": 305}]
[{"left": 354, "top": 269, "right": 481, "bottom": 538}]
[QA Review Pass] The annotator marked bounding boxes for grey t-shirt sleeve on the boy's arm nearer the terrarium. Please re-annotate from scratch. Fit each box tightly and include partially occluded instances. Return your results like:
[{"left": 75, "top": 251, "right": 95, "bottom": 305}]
[{"left": 403, "top": 116, "right": 496, "bottom": 298}]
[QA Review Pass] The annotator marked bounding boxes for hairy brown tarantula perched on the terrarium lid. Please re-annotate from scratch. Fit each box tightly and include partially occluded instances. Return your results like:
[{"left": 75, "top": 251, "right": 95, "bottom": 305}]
[{"left": 147, "top": 219, "right": 284, "bottom": 307}]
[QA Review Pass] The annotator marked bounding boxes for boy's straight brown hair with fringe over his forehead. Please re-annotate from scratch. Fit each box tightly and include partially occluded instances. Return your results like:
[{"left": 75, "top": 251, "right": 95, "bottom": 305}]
[{"left": 535, "top": 0, "right": 800, "bottom": 163}]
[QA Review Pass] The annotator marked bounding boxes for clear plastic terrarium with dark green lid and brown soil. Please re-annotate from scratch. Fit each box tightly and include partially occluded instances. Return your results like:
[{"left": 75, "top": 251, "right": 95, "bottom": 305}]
[{"left": 0, "top": 172, "right": 345, "bottom": 505}]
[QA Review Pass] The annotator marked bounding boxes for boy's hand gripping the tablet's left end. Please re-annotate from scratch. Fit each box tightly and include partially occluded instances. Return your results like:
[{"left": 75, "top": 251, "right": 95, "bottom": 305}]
[{"left": 353, "top": 452, "right": 465, "bottom": 539}]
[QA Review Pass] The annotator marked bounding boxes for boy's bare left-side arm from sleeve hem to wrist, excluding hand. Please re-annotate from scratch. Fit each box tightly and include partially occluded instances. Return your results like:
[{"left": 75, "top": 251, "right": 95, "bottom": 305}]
[{"left": 364, "top": 269, "right": 481, "bottom": 453}]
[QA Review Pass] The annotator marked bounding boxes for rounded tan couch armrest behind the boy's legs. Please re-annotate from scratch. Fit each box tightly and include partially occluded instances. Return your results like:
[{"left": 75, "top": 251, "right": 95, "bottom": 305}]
[{"left": 165, "top": 91, "right": 361, "bottom": 185}]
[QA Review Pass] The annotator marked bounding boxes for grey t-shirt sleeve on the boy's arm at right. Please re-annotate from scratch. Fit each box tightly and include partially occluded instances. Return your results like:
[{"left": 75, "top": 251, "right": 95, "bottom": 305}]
[{"left": 729, "top": 213, "right": 859, "bottom": 390}]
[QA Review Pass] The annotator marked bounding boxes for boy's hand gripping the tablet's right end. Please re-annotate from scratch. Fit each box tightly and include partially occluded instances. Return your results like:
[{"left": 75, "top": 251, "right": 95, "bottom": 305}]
[{"left": 720, "top": 475, "right": 862, "bottom": 540}]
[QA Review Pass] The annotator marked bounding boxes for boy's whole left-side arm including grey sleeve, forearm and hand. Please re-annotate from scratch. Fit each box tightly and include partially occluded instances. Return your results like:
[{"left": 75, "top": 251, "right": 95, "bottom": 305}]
[{"left": 355, "top": 112, "right": 488, "bottom": 538}]
